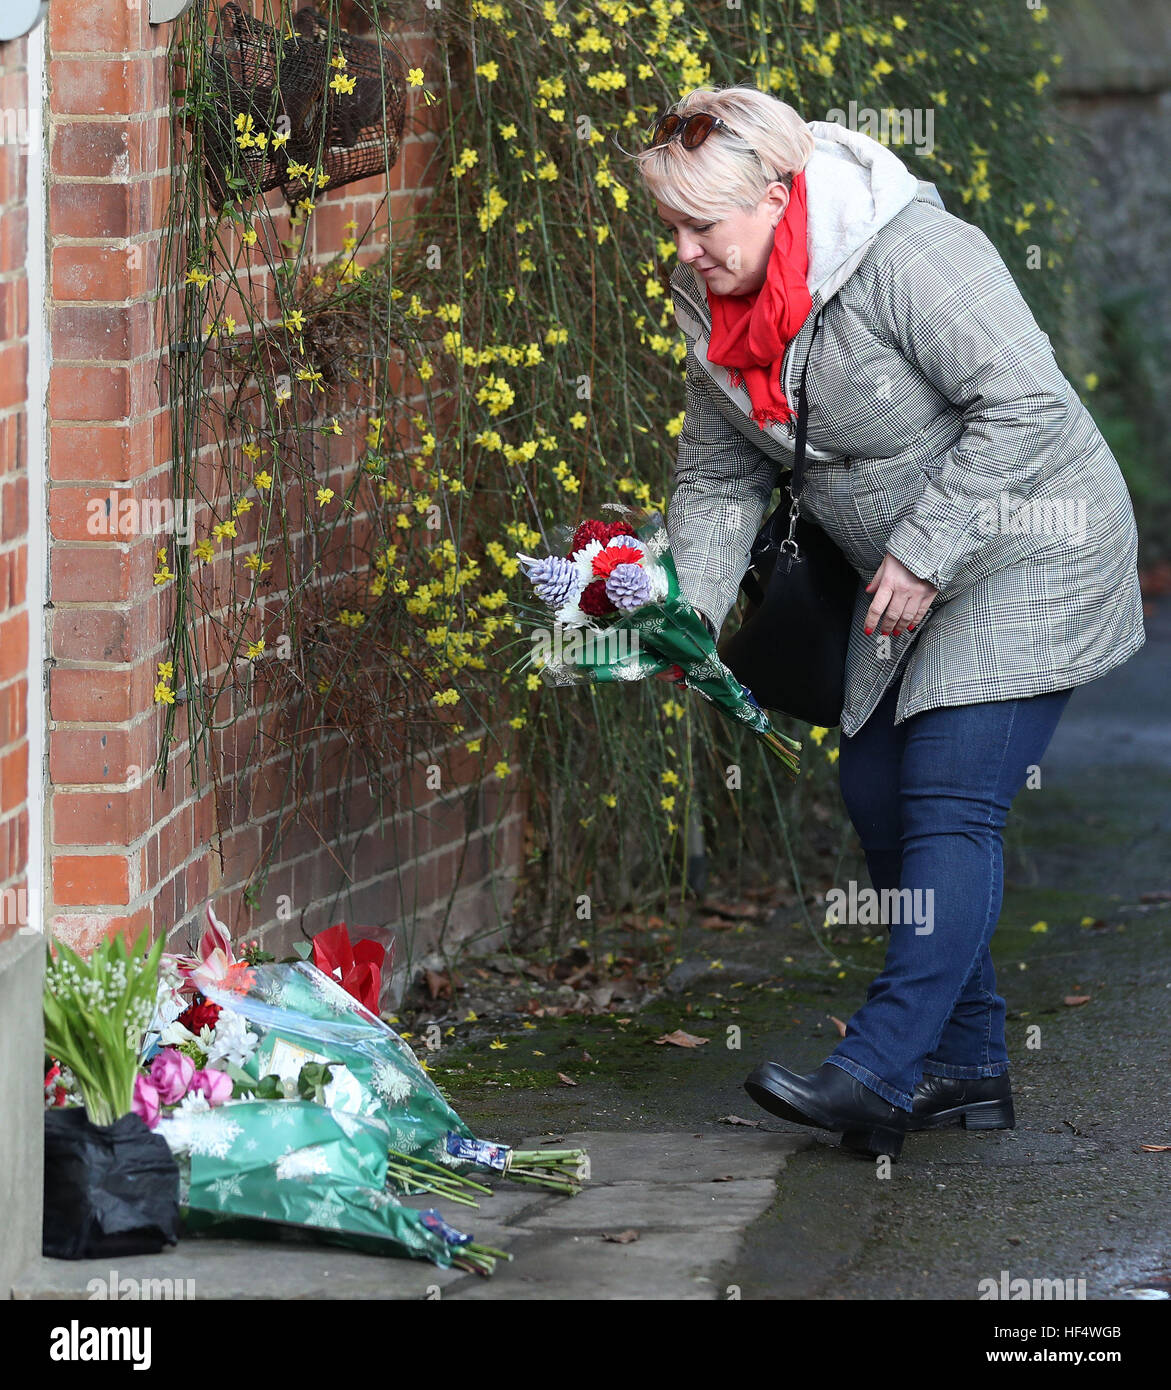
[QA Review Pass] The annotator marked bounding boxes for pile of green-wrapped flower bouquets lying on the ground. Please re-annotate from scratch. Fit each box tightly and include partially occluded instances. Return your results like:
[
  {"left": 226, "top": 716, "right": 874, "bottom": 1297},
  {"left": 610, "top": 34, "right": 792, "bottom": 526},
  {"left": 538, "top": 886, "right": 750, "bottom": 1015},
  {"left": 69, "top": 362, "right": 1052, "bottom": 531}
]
[{"left": 128, "top": 905, "right": 586, "bottom": 1273}]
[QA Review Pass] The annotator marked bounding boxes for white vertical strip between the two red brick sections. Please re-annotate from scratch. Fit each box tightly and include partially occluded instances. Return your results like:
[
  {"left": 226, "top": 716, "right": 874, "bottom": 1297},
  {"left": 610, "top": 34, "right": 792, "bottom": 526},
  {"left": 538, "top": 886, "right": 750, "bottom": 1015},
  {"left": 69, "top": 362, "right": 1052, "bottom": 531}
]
[{"left": 25, "top": 16, "right": 51, "bottom": 931}]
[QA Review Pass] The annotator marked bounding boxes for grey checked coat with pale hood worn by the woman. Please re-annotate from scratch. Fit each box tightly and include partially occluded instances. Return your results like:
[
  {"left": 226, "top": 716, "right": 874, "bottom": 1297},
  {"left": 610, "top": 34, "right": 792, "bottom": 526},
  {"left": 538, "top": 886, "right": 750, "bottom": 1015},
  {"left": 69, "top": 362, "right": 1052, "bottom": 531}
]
[{"left": 668, "top": 121, "right": 1145, "bottom": 735}]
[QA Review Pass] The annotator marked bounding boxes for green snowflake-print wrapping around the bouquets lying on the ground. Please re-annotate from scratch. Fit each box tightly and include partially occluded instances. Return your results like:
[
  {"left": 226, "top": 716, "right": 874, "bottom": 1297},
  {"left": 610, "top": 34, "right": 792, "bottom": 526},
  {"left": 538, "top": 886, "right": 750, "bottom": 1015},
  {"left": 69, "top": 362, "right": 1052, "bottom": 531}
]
[{"left": 159, "top": 960, "right": 492, "bottom": 1268}]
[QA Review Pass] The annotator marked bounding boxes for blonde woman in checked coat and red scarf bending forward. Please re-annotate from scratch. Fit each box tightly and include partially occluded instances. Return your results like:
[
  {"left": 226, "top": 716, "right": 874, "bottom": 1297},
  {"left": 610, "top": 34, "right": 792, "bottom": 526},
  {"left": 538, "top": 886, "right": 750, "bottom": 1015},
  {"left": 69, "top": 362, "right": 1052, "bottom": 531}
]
[{"left": 634, "top": 86, "right": 1145, "bottom": 1156}]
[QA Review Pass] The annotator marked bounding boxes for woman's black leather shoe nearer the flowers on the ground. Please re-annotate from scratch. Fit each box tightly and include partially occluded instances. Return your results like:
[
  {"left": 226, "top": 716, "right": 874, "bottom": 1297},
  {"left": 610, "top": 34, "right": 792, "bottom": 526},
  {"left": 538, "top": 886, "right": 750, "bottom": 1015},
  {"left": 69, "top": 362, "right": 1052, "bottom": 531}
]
[{"left": 744, "top": 1062, "right": 911, "bottom": 1159}]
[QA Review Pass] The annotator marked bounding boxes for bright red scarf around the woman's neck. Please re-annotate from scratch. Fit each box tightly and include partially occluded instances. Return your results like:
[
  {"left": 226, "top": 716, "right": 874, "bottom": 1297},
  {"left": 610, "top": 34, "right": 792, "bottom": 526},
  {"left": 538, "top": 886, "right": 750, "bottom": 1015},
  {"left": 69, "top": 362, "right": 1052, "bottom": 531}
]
[{"left": 698, "top": 170, "right": 814, "bottom": 430}]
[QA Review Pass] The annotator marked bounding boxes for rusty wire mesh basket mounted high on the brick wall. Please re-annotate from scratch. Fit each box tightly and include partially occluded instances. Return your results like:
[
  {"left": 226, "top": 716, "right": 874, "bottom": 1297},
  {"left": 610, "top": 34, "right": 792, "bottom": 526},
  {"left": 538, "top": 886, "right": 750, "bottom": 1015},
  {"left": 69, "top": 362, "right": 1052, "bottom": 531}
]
[{"left": 204, "top": 4, "right": 406, "bottom": 204}]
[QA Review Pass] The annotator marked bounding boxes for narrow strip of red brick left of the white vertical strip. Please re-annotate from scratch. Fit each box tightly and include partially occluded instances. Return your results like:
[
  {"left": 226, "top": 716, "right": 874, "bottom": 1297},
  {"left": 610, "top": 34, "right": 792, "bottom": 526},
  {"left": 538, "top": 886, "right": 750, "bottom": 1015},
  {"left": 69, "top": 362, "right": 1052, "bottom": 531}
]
[{"left": 0, "top": 39, "right": 29, "bottom": 940}]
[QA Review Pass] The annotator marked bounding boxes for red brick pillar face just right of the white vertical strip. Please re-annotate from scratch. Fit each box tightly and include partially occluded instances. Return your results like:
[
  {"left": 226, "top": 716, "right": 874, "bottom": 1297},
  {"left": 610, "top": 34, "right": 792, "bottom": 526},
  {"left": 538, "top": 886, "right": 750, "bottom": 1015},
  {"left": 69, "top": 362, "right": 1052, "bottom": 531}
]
[{"left": 47, "top": 0, "right": 174, "bottom": 947}]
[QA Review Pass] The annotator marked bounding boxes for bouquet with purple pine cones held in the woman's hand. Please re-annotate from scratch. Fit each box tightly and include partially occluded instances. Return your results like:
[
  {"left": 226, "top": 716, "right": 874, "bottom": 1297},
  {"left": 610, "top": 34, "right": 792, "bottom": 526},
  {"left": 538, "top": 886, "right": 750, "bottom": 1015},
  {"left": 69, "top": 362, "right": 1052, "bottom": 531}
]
[{"left": 517, "top": 502, "right": 801, "bottom": 777}]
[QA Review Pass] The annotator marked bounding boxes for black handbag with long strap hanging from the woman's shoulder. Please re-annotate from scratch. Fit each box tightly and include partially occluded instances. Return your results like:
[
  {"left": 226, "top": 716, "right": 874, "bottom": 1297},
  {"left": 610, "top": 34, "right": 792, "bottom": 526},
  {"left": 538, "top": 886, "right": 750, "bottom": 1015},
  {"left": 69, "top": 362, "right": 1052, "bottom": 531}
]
[{"left": 716, "top": 310, "right": 859, "bottom": 728}]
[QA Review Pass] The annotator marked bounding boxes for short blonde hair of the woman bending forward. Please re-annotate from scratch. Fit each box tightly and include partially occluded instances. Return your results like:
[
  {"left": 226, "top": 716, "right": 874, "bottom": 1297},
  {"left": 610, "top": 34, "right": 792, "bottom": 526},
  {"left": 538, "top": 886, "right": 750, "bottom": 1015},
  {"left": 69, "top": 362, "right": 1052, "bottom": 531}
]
[{"left": 631, "top": 86, "right": 814, "bottom": 221}]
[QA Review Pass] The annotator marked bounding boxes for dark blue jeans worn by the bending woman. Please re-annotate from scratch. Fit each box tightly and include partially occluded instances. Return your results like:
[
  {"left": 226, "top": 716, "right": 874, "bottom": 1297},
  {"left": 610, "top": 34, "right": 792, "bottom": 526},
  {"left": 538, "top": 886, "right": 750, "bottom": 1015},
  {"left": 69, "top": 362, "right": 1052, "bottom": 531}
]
[{"left": 826, "top": 680, "right": 1072, "bottom": 1111}]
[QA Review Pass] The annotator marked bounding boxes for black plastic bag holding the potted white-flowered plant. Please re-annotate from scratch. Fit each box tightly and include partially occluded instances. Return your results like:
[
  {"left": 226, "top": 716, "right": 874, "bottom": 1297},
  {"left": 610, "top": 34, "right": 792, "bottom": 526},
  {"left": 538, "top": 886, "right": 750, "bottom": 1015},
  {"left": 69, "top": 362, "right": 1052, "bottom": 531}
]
[{"left": 42, "top": 1106, "right": 179, "bottom": 1259}]
